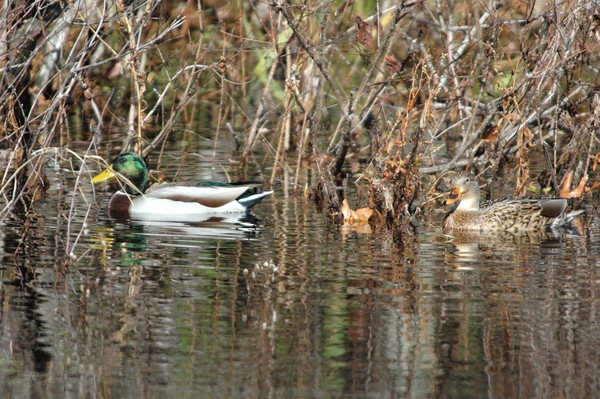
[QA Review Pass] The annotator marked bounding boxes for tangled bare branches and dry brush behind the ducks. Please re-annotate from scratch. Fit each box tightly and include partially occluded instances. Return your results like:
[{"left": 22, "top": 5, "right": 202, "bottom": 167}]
[{"left": 0, "top": 0, "right": 600, "bottom": 230}]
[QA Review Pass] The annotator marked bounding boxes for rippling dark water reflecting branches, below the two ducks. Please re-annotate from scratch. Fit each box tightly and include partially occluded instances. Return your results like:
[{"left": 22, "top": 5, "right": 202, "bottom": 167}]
[{"left": 0, "top": 148, "right": 600, "bottom": 398}]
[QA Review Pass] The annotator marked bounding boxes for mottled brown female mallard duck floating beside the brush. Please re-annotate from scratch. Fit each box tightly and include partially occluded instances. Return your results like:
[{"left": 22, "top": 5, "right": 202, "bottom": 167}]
[{"left": 442, "top": 175, "right": 581, "bottom": 232}]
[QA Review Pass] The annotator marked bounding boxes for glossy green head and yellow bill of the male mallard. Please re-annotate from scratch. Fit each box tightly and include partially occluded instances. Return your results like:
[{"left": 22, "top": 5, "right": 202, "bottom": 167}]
[{"left": 91, "top": 152, "right": 148, "bottom": 195}]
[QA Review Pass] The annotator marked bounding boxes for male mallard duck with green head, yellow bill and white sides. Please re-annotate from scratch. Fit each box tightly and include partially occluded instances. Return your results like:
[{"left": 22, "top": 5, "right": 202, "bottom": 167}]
[{"left": 91, "top": 152, "right": 273, "bottom": 221}]
